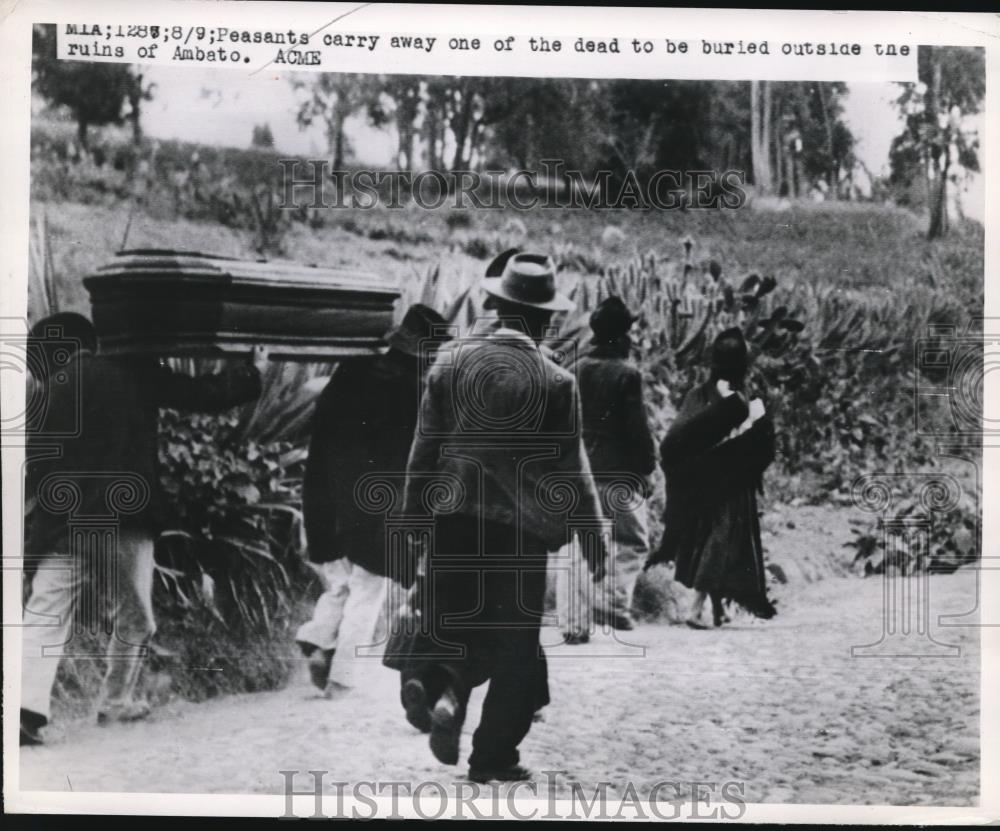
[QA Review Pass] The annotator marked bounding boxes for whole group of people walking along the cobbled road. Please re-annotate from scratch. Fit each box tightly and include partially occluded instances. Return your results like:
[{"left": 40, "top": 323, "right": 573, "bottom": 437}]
[{"left": 21, "top": 250, "right": 774, "bottom": 782}]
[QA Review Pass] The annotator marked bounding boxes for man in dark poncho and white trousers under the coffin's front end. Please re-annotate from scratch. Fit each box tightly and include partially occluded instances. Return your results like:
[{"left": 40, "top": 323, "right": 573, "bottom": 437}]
[{"left": 295, "top": 303, "right": 447, "bottom": 696}]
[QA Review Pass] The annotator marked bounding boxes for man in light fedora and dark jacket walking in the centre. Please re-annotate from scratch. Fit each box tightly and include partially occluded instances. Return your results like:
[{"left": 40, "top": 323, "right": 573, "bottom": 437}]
[{"left": 404, "top": 254, "right": 606, "bottom": 782}]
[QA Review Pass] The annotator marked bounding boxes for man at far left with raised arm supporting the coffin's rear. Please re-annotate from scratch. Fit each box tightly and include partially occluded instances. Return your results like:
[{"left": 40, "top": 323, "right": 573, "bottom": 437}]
[{"left": 21, "top": 313, "right": 267, "bottom": 745}]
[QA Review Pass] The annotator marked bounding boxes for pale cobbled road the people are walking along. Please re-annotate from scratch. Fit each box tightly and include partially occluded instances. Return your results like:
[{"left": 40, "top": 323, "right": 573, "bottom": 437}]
[{"left": 21, "top": 571, "right": 980, "bottom": 805}]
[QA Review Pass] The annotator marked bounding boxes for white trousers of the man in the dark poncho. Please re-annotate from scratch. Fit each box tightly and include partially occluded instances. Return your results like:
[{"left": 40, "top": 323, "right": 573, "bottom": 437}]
[{"left": 295, "top": 557, "right": 389, "bottom": 687}]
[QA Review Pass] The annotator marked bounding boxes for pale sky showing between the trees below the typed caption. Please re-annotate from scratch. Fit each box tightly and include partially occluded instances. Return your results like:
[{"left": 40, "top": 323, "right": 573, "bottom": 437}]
[{"left": 143, "top": 66, "right": 983, "bottom": 220}]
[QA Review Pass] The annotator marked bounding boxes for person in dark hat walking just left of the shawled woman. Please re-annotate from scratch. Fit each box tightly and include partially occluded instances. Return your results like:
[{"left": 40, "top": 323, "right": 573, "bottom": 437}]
[{"left": 566, "top": 296, "right": 656, "bottom": 632}]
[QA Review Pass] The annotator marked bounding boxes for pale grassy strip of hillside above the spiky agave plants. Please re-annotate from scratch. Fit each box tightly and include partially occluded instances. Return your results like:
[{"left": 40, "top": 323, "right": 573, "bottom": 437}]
[{"left": 28, "top": 200, "right": 983, "bottom": 326}]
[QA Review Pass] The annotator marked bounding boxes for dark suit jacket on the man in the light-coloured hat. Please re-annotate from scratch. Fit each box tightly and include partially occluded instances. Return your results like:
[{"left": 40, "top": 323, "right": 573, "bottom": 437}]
[{"left": 405, "top": 323, "right": 602, "bottom": 557}]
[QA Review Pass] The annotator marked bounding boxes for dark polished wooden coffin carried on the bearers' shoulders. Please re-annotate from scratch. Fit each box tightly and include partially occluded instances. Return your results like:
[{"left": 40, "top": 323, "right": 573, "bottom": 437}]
[{"left": 83, "top": 249, "right": 399, "bottom": 361}]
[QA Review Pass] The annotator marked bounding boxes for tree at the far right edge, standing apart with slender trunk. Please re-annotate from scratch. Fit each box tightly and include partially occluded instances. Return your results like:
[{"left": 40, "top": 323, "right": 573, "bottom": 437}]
[{"left": 889, "top": 46, "right": 986, "bottom": 239}]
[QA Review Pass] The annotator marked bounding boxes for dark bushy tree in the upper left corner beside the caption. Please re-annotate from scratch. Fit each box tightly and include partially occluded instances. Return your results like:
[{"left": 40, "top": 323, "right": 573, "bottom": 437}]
[{"left": 32, "top": 24, "right": 141, "bottom": 149}]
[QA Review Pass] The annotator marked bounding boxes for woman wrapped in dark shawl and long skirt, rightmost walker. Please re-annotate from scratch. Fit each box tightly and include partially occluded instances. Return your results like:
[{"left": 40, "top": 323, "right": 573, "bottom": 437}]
[{"left": 646, "top": 328, "right": 775, "bottom": 629}]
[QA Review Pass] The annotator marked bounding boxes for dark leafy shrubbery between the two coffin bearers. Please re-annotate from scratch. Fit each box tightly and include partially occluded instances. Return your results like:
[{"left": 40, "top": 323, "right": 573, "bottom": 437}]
[{"left": 156, "top": 410, "right": 315, "bottom": 699}]
